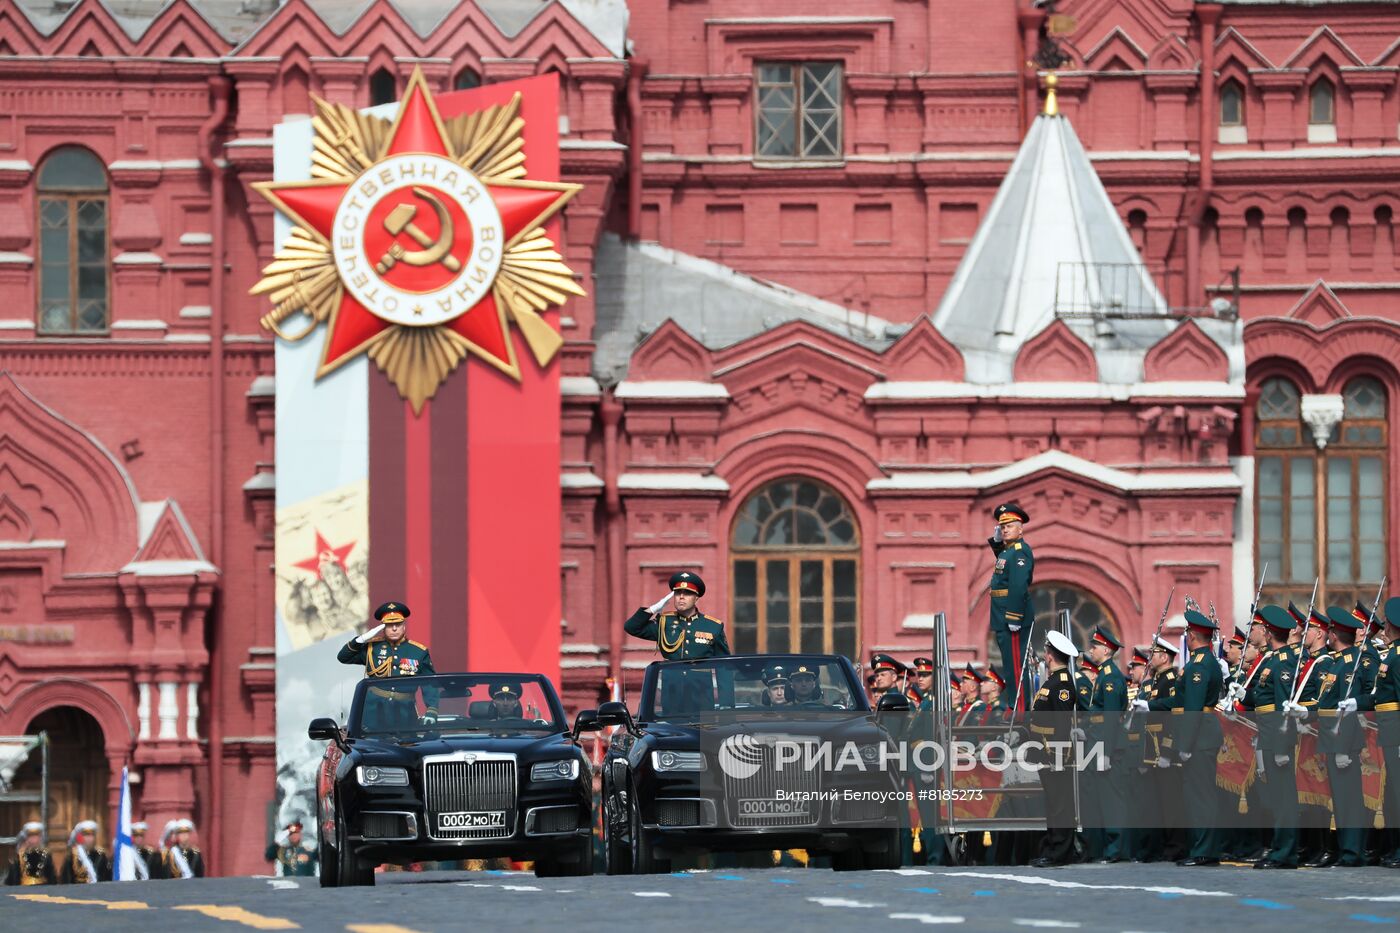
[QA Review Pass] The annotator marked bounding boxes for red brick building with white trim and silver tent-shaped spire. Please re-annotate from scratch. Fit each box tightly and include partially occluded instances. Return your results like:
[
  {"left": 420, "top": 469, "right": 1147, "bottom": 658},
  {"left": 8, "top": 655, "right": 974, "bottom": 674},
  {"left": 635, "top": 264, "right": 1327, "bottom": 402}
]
[{"left": 0, "top": 0, "right": 1400, "bottom": 873}]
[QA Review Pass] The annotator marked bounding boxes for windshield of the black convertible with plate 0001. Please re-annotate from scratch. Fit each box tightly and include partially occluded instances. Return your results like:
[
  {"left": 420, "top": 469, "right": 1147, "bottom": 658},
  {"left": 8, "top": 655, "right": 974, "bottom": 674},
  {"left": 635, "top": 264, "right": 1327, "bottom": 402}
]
[{"left": 641, "top": 654, "right": 869, "bottom": 721}]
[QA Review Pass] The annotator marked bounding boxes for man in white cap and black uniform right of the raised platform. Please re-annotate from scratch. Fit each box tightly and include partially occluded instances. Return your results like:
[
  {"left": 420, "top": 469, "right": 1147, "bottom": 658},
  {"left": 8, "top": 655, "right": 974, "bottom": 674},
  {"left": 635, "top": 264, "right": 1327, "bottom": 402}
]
[{"left": 1030, "top": 630, "right": 1079, "bottom": 869}]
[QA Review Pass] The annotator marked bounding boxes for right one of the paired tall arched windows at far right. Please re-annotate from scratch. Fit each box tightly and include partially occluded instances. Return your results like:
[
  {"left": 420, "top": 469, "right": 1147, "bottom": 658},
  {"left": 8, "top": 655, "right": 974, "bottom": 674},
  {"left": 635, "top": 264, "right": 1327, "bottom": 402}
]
[{"left": 1326, "top": 375, "right": 1389, "bottom": 607}]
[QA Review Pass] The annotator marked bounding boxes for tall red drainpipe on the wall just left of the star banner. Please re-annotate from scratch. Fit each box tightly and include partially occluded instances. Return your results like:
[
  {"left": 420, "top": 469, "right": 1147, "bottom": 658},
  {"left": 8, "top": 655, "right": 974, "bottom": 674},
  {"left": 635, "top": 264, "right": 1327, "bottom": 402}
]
[{"left": 197, "top": 74, "right": 232, "bottom": 876}]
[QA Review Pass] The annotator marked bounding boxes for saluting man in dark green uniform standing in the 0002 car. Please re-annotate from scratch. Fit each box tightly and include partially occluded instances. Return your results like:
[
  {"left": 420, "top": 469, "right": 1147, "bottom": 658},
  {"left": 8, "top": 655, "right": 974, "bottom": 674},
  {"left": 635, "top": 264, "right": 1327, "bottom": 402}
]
[{"left": 336, "top": 602, "right": 440, "bottom": 730}]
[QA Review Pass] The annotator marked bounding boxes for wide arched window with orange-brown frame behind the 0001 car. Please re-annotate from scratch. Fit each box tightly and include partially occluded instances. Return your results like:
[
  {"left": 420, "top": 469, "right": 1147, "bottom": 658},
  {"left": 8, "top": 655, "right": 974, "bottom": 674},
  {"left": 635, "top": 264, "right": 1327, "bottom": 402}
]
[{"left": 729, "top": 478, "right": 860, "bottom": 658}]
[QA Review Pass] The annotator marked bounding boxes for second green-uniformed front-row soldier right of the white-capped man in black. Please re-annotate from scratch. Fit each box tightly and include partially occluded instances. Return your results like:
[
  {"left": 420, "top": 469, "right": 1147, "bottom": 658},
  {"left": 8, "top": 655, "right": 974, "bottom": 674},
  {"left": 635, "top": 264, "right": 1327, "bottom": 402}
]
[{"left": 1172, "top": 609, "right": 1225, "bottom": 866}]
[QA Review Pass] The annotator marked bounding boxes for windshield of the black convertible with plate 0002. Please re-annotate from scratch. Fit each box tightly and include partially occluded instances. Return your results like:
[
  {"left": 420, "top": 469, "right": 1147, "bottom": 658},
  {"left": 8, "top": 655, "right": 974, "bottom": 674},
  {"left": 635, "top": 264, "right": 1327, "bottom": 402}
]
[{"left": 349, "top": 674, "right": 564, "bottom": 737}]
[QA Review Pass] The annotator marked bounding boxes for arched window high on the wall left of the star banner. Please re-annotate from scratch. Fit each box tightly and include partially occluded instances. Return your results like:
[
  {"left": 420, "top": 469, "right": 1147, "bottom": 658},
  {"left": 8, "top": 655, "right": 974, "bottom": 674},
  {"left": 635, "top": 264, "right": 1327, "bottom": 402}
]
[{"left": 38, "top": 146, "right": 111, "bottom": 335}]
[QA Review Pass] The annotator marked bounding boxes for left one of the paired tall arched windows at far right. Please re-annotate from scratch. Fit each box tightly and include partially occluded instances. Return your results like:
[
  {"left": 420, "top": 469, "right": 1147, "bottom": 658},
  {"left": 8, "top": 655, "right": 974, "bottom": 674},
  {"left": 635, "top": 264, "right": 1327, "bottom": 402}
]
[{"left": 1254, "top": 378, "right": 1317, "bottom": 601}]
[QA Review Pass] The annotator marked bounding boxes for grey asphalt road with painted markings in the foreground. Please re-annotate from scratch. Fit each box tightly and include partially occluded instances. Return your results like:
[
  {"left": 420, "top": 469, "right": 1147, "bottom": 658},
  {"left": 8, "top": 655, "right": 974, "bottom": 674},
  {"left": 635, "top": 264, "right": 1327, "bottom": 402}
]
[{"left": 8, "top": 864, "right": 1400, "bottom": 933}]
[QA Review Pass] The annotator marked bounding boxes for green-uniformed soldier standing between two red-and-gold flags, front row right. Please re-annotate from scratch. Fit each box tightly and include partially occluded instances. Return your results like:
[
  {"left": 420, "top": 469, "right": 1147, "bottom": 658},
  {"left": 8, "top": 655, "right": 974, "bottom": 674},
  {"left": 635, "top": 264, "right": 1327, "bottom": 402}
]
[{"left": 1242, "top": 605, "right": 1298, "bottom": 869}]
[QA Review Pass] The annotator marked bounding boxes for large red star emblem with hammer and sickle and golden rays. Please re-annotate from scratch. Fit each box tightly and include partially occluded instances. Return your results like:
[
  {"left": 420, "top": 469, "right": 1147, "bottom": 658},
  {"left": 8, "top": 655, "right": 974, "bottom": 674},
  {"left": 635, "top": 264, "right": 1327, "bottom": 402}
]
[{"left": 255, "top": 70, "right": 581, "bottom": 405}]
